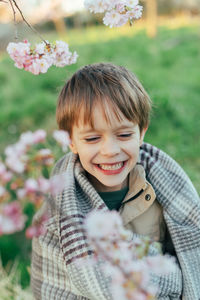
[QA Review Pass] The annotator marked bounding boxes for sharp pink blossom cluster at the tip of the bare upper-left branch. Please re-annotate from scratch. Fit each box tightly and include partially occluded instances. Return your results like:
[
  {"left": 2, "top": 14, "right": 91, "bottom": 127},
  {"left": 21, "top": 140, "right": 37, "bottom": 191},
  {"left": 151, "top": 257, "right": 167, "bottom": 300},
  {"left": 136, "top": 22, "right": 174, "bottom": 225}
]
[{"left": 7, "top": 40, "right": 78, "bottom": 75}]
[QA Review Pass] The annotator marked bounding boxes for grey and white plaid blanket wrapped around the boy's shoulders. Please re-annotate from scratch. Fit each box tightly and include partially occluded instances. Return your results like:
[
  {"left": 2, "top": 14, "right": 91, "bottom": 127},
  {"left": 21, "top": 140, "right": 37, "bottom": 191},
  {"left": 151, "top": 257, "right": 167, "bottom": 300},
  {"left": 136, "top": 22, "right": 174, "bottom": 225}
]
[{"left": 31, "top": 143, "right": 200, "bottom": 300}]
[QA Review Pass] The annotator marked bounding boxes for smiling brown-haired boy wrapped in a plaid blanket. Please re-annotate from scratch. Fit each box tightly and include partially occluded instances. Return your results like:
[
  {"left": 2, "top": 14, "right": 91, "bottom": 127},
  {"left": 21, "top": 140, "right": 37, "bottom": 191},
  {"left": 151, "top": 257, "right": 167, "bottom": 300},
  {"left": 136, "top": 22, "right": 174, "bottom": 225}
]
[{"left": 32, "top": 63, "right": 200, "bottom": 300}]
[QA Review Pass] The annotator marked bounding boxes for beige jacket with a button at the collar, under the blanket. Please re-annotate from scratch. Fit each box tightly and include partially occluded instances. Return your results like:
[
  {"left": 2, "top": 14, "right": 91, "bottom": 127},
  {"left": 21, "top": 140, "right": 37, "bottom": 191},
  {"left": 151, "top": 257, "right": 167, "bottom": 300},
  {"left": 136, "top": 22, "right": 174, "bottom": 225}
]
[{"left": 119, "top": 165, "right": 166, "bottom": 243}]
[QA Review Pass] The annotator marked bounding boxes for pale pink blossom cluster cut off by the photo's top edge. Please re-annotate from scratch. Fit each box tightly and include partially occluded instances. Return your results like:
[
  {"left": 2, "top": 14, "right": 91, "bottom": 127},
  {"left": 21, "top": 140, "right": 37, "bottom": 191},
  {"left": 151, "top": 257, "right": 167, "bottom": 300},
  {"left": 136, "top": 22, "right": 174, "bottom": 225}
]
[{"left": 84, "top": 0, "right": 143, "bottom": 27}]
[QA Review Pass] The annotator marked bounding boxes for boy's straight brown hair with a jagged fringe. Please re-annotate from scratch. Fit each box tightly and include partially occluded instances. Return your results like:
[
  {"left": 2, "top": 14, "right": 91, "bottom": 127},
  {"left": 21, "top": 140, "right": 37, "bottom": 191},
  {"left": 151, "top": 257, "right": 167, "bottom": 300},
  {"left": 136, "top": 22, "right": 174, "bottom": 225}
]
[{"left": 56, "top": 63, "right": 151, "bottom": 135}]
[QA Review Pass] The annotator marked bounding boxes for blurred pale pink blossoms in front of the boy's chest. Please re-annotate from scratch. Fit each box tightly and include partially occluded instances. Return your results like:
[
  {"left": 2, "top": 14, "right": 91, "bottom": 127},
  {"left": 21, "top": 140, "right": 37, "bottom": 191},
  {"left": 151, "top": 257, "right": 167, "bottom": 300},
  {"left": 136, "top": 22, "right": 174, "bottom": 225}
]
[{"left": 85, "top": 211, "right": 174, "bottom": 300}]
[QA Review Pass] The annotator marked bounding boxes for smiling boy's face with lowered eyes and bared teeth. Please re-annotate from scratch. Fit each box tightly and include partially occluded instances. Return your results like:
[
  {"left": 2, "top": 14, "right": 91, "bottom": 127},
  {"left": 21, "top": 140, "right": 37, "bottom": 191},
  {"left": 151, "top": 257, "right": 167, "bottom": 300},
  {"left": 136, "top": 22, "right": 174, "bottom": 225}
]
[{"left": 70, "top": 104, "right": 146, "bottom": 192}]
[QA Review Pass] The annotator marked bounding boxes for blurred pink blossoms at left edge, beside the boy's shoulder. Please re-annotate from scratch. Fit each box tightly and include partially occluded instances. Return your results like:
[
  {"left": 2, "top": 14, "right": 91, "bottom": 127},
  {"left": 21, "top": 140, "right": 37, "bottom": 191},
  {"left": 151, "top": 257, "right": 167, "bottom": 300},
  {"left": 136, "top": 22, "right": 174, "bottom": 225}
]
[{"left": 0, "top": 129, "right": 70, "bottom": 238}]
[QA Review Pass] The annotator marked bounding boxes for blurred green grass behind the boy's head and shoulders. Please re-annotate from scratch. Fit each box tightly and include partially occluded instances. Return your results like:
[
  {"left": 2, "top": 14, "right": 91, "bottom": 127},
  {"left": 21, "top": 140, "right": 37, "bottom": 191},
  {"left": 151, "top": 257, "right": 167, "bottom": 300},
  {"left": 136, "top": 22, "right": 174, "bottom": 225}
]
[{"left": 0, "top": 26, "right": 200, "bottom": 192}]
